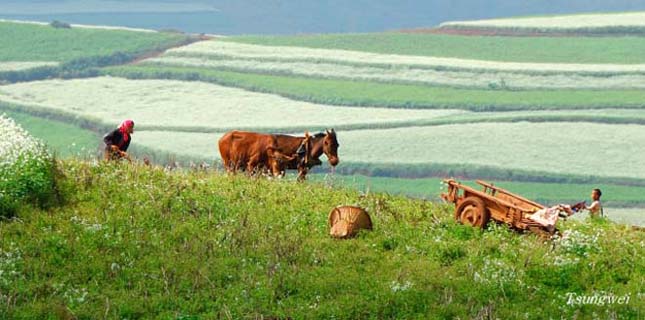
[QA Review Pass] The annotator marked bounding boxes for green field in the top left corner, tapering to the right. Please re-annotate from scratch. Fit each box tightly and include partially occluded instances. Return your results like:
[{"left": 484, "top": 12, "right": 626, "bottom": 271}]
[{"left": 0, "top": 22, "right": 185, "bottom": 62}]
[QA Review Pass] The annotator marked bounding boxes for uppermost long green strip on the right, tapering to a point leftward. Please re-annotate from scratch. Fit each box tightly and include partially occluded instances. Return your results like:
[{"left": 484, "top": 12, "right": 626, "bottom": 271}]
[{"left": 228, "top": 33, "right": 645, "bottom": 64}]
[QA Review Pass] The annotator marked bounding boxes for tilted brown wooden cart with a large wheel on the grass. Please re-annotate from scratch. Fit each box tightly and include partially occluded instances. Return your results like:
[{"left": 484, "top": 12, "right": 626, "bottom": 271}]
[{"left": 441, "top": 179, "right": 556, "bottom": 235}]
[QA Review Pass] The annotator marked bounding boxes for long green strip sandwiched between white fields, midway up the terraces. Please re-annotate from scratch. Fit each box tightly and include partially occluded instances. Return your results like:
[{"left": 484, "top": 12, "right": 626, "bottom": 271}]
[{"left": 102, "top": 66, "right": 645, "bottom": 111}]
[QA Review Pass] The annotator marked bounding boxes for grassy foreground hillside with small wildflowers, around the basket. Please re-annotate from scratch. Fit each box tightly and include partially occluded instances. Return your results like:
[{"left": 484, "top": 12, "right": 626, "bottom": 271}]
[{"left": 0, "top": 162, "right": 645, "bottom": 319}]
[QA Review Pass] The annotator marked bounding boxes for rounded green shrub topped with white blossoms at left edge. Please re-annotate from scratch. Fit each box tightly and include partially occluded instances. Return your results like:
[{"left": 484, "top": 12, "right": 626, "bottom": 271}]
[{"left": 0, "top": 115, "right": 55, "bottom": 217}]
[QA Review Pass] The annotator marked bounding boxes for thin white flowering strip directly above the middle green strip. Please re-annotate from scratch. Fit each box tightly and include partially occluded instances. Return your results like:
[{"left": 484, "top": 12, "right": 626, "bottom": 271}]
[{"left": 144, "top": 55, "right": 645, "bottom": 89}]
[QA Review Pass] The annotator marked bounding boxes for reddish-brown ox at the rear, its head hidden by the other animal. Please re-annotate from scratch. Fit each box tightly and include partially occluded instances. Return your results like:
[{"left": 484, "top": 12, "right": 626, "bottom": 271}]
[{"left": 218, "top": 131, "right": 295, "bottom": 176}]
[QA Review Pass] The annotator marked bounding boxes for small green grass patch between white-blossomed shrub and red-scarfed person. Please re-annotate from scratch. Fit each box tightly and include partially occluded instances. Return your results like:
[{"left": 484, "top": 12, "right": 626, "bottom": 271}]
[{"left": 0, "top": 110, "right": 101, "bottom": 158}]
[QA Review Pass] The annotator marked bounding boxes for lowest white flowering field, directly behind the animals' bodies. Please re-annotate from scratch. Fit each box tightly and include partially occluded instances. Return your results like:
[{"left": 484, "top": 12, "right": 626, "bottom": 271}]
[{"left": 131, "top": 122, "right": 645, "bottom": 178}]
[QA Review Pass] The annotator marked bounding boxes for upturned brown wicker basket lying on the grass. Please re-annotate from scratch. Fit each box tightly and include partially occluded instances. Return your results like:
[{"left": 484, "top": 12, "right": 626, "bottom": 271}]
[{"left": 329, "top": 206, "right": 372, "bottom": 238}]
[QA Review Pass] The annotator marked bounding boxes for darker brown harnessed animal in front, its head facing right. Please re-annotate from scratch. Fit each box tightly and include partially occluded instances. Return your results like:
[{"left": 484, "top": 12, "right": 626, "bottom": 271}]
[{"left": 275, "top": 129, "right": 340, "bottom": 180}]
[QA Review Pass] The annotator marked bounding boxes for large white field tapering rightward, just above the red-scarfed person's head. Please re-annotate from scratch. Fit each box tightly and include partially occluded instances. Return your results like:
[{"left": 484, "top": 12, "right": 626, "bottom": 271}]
[{"left": 0, "top": 77, "right": 464, "bottom": 131}]
